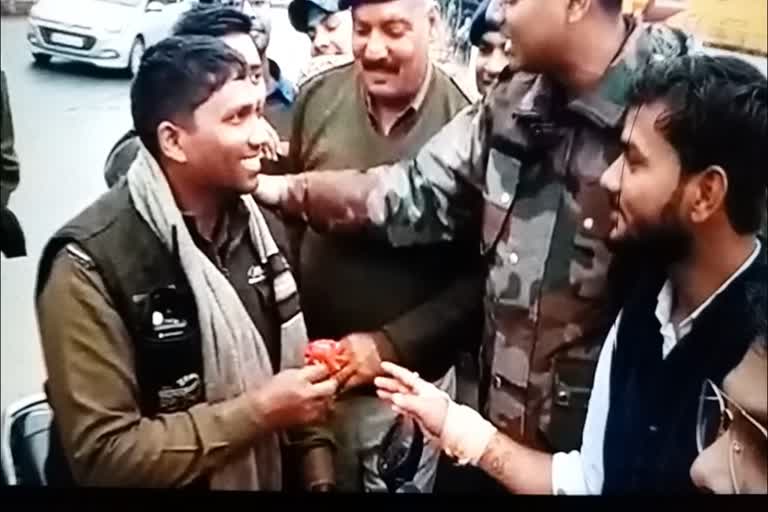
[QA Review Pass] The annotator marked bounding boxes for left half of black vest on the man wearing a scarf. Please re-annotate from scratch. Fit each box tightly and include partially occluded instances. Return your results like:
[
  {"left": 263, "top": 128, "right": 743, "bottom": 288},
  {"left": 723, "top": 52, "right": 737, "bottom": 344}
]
[{"left": 37, "top": 180, "right": 205, "bottom": 486}]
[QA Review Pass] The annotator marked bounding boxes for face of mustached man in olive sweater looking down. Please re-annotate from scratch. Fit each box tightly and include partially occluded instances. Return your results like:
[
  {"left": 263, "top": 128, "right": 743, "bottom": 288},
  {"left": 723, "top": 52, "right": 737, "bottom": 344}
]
[{"left": 352, "top": 0, "right": 437, "bottom": 102}]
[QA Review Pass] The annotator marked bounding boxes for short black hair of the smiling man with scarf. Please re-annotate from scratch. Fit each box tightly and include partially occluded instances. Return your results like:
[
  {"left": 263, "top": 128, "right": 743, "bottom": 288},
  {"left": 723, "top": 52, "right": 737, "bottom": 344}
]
[{"left": 131, "top": 35, "right": 248, "bottom": 158}]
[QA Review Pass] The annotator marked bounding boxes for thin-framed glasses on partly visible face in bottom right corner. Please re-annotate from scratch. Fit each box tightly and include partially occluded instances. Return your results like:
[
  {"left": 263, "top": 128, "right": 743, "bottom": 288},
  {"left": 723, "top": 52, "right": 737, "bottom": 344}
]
[{"left": 696, "top": 379, "right": 768, "bottom": 494}]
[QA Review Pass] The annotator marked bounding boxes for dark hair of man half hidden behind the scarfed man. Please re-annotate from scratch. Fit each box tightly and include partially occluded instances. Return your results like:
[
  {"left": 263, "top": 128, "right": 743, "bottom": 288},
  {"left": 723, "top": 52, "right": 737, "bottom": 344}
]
[{"left": 173, "top": 5, "right": 253, "bottom": 37}]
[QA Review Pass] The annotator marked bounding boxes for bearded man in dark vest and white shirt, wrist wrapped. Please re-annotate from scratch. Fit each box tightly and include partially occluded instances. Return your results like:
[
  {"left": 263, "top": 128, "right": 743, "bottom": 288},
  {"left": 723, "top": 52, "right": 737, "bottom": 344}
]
[{"left": 377, "top": 51, "right": 768, "bottom": 494}]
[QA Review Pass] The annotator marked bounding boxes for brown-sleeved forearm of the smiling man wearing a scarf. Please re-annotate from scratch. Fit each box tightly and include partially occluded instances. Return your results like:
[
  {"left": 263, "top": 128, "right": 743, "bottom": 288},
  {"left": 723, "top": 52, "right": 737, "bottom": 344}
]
[{"left": 62, "top": 390, "right": 269, "bottom": 487}]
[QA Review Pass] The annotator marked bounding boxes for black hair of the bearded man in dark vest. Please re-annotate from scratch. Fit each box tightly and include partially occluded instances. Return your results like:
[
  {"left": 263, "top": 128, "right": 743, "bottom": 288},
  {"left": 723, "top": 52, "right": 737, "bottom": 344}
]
[{"left": 630, "top": 54, "right": 768, "bottom": 234}]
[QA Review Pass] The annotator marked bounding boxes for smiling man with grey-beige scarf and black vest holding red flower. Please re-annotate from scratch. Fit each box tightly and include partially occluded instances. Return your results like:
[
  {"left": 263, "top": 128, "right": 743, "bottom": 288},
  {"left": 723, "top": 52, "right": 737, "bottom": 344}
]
[{"left": 36, "top": 35, "right": 337, "bottom": 491}]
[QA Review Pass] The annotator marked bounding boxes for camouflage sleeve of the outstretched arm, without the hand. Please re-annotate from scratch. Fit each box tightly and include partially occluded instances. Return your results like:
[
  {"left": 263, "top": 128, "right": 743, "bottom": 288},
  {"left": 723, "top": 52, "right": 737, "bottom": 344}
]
[{"left": 280, "top": 104, "right": 487, "bottom": 246}]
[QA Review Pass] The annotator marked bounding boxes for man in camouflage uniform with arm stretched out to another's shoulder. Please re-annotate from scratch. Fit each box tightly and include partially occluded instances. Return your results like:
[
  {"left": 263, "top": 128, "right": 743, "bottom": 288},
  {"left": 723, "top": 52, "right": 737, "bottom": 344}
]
[{"left": 258, "top": 0, "right": 687, "bottom": 450}]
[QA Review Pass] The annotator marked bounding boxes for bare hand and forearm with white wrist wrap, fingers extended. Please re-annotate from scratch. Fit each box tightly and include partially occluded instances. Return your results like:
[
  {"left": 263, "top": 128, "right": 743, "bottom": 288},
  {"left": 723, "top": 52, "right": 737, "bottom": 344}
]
[{"left": 374, "top": 362, "right": 552, "bottom": 494}]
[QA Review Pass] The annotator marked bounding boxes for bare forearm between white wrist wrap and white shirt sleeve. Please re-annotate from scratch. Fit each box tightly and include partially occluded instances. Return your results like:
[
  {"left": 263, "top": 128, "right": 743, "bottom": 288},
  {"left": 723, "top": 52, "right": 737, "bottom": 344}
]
[{"left": 479, "top": 432, "right": 552, "bottom": 494}]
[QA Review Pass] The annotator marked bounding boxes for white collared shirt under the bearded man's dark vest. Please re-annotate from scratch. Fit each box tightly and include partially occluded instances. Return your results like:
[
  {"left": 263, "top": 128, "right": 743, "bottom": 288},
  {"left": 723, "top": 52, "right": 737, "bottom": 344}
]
[{"left": 552, "top": 240, "right": 761, "bottom": 494}]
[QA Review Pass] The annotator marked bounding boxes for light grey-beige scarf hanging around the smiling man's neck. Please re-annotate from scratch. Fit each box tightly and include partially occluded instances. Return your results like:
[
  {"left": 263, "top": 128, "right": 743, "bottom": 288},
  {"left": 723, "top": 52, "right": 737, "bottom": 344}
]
[{"left": 127, "top": 145, "right": 307, "bottom": 490}]
